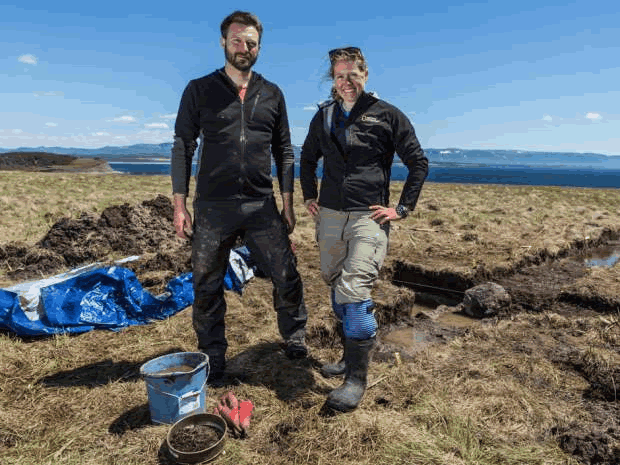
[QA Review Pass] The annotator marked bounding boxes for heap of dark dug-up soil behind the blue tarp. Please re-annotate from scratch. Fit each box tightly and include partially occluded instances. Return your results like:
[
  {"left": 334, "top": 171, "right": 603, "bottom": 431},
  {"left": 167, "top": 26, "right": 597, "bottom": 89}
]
[{"left": 0, "top": 195, "right": 191, "bottom": 287}]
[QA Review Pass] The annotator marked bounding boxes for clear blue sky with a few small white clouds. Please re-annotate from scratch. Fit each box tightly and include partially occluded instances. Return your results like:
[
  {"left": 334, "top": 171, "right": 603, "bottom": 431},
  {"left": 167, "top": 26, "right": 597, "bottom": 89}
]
[{"left": 0, "top": 0, "right": 620, "bottom": 155}]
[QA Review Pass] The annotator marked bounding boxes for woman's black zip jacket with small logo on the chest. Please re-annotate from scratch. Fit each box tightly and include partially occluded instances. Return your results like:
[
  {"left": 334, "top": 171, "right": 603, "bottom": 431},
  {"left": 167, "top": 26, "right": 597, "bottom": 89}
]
[{"left": 301, "top": 93, "right": 428, "bottom": 211}]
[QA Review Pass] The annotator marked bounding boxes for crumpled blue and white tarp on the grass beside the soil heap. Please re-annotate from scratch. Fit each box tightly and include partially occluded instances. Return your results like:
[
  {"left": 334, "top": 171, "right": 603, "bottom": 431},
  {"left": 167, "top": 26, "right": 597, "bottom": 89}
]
[{"left": 0, "top": 247, "right": 254, "bottom": 336}]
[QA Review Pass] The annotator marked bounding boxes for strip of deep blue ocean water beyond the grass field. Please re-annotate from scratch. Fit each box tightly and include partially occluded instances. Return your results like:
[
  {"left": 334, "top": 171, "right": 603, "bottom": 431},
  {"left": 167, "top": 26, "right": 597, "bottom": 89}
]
[{"left": 109, "top": 162, "right": 620, "bottom": 188}]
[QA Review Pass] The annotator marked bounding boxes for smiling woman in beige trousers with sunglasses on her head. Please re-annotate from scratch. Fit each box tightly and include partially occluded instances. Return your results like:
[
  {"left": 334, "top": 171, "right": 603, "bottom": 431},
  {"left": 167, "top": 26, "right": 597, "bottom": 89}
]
[{"left": 301, "top": 47, "right": 428, "bottom": 412}]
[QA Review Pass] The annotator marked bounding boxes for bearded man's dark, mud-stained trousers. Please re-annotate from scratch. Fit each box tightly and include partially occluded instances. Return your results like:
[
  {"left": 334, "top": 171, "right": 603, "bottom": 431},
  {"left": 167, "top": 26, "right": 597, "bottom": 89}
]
[{"left": 192, "top": 196, "right": 308, "bottom": 375}]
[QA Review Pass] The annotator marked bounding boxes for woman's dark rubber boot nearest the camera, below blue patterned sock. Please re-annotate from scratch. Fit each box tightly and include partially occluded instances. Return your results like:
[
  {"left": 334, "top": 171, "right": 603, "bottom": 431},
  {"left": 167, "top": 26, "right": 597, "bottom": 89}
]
[{"left": 325, "top": 337, "right": 375, "bottom": 412}]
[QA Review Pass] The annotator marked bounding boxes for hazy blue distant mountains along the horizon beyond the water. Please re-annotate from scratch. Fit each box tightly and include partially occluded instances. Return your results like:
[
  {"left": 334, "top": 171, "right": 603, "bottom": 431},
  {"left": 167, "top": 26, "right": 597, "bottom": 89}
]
[{"left": 0, "top": 143, "right": 620, "bottom": 169}]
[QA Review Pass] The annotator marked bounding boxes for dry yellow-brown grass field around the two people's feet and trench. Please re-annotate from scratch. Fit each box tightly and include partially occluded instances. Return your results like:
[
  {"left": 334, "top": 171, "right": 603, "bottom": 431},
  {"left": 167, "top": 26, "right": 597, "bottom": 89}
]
[{"left": 0, "top": 171, "right": 620, "bottom": 465}]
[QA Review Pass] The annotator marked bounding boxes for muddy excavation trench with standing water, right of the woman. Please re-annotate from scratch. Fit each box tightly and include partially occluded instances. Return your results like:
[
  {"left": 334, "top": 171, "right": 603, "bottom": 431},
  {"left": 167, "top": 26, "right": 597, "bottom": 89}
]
[{"left": 375, "top": 230, "right": 620, "bottom": 378}]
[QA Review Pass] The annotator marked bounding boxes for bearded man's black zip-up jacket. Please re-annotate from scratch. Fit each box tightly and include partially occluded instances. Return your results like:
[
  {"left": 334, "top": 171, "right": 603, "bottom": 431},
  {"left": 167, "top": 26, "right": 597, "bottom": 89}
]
[{"left": 171, "top": 68, "right": 294, "bottom": 200}]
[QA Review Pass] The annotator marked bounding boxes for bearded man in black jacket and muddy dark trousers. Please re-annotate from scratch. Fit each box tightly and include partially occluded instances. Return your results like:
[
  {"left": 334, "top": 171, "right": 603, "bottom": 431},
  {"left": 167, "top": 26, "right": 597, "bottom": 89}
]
[{"left": 171, "top": 11, "right": 307, "bottom": 383}]
